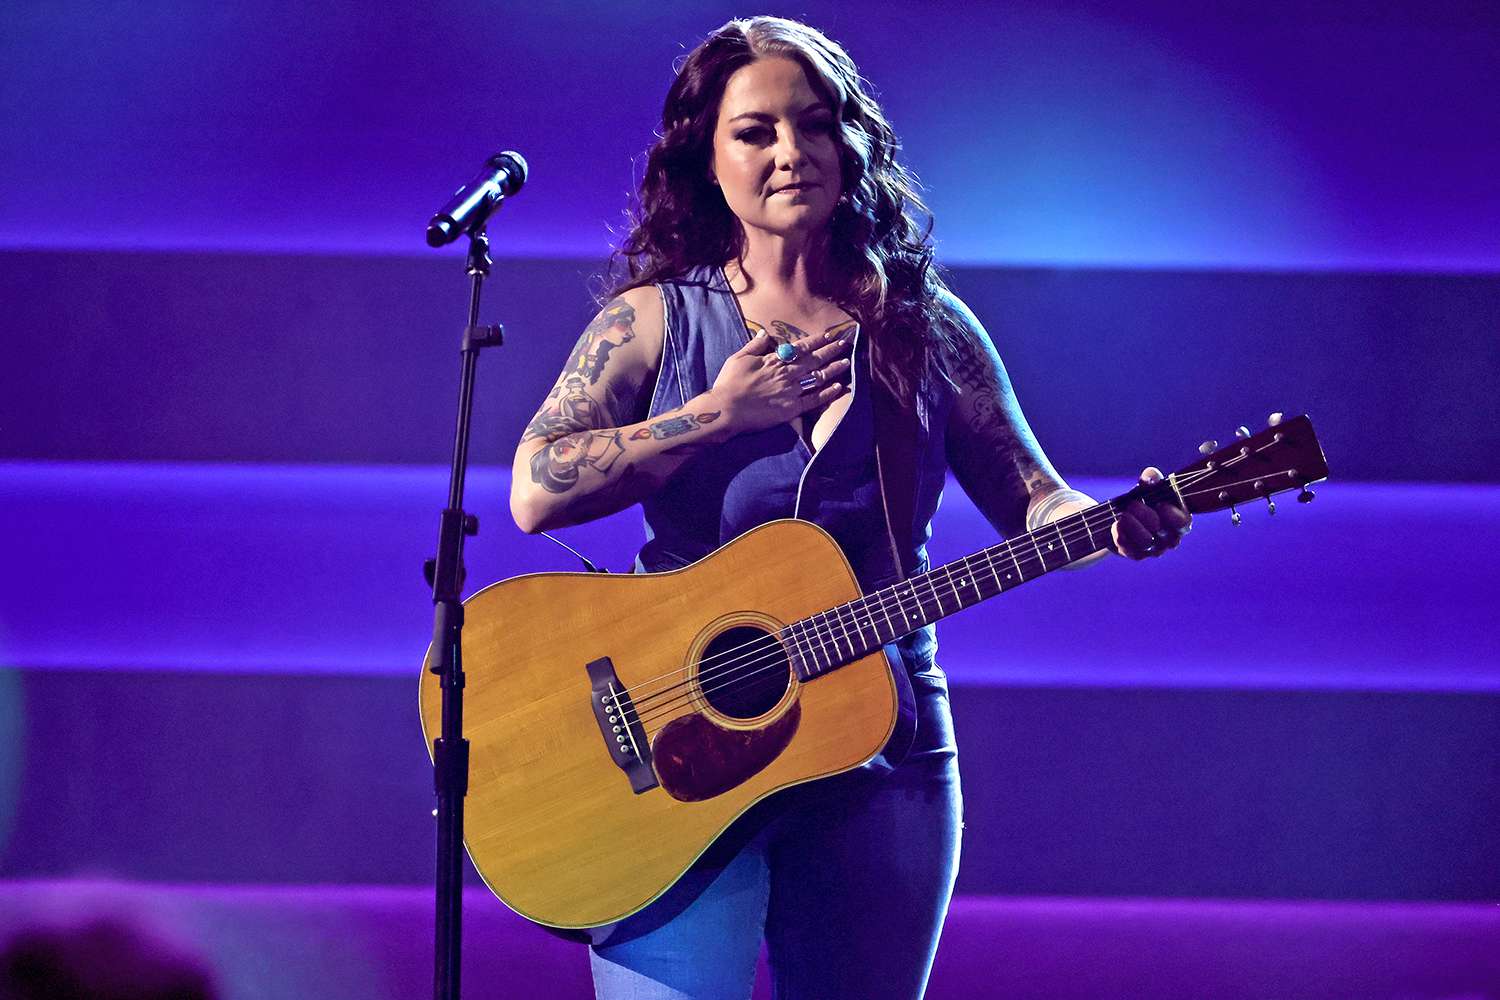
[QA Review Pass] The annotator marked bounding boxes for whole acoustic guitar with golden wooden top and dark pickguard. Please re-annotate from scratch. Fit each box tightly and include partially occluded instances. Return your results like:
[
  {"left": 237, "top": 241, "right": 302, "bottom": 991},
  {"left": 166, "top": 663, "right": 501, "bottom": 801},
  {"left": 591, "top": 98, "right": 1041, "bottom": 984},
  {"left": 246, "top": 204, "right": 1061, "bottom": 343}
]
[{"left": 420, "top": 417, "right": 1328, "bottom": 928}]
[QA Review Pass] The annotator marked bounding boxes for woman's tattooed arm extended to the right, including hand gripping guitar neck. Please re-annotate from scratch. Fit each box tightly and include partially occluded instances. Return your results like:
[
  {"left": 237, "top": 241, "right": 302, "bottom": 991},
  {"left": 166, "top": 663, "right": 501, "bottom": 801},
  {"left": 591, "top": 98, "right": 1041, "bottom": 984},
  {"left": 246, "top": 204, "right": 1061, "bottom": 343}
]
[{"left": 944, "top": 297, "right": 1191, "bottom": 562}]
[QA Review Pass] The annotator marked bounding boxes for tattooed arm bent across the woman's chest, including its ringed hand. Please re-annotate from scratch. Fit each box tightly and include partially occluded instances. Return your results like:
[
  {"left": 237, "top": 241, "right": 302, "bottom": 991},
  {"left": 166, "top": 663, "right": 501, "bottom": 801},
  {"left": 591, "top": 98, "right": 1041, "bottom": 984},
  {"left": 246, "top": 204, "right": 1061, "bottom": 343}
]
[{"left": 510, "top": 288, "right": 846, "bottom": 532}]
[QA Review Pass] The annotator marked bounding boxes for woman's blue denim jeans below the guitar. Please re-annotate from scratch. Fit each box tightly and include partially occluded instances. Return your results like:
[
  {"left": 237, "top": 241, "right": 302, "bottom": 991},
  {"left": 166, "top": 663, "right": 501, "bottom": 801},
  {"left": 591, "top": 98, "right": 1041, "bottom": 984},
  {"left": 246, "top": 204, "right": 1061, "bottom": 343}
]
[{"left": 591, "top": 666, "right": 963, "bottom": 1000}]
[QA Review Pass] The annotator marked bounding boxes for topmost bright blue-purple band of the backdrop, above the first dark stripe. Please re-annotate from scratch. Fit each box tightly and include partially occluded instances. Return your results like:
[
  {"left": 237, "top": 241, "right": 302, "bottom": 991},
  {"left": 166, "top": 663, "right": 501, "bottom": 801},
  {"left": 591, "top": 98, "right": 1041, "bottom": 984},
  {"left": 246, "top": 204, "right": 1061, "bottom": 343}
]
[{"left": 0, "top": 0, "right": 1500, "bottom": 271}]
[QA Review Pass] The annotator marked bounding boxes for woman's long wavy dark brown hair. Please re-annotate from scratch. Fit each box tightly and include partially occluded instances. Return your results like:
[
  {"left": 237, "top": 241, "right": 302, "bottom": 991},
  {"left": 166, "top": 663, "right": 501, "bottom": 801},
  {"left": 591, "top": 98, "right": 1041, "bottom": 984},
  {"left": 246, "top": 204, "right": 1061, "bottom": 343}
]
[{"left": 606, "top": 16, "right": 962, "bottom": 388}]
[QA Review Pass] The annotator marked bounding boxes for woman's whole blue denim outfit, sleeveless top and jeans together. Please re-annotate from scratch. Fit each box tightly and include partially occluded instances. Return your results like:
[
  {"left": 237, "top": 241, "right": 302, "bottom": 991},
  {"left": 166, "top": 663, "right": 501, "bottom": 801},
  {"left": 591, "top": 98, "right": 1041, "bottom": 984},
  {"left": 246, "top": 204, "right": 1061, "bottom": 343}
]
[{"left": 591, "top": 268, "right": 962, "bottom": 1000}]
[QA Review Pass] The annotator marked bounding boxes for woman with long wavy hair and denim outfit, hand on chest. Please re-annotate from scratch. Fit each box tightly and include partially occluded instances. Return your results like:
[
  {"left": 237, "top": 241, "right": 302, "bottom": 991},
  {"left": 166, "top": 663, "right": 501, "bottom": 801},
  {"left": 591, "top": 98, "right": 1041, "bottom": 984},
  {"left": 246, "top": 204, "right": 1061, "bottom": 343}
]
[{"left": 512, "top": 18, "right": 1188, "bottom": 999}]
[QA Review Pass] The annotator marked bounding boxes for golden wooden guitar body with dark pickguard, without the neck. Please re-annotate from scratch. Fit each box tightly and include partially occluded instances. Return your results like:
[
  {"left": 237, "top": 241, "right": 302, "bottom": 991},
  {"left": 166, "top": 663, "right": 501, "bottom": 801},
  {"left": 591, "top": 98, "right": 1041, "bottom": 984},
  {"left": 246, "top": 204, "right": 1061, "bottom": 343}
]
[{"left": 420, "top": 520, "right": 912, "bottom": 928}]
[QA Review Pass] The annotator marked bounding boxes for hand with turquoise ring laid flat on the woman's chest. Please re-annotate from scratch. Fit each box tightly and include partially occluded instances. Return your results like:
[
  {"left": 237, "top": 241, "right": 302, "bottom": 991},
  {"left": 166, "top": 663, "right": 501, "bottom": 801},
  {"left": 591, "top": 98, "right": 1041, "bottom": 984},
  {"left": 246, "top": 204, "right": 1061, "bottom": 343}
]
[{"left": 707, "top": 331, "right": 854, "bottom": 433}]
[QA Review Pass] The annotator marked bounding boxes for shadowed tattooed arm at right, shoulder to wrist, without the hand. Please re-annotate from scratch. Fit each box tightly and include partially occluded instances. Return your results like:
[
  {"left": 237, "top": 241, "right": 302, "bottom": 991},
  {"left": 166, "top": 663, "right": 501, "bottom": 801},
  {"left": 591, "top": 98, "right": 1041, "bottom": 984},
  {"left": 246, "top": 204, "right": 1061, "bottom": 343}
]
[{"left": 947, "top": 289, "right": 1088, "bottom": 535}]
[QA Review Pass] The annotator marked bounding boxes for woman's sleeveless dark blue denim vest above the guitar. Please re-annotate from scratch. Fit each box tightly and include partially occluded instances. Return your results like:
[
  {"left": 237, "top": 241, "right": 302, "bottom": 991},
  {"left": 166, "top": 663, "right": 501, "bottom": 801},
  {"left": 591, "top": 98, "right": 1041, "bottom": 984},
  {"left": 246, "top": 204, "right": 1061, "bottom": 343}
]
[{"left": 636, "top": 267, "right": 951, "bottom": 670}]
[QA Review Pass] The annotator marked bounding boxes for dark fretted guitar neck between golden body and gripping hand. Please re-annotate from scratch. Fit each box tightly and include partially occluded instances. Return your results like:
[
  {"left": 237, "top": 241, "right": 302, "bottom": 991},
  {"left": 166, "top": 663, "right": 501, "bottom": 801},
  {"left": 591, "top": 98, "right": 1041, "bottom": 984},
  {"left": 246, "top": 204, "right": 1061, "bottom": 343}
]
[{"left": 783, "top": 477, "right": 1146, "bottom": 681}]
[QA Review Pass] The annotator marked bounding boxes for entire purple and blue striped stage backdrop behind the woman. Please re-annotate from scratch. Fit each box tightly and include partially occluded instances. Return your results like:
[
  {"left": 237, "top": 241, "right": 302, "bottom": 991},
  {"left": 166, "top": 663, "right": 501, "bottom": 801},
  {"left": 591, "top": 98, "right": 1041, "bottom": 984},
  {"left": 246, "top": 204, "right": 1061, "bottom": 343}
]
[{"left": 0, "top": 0, "right": 1500, "bottom": 999}]
